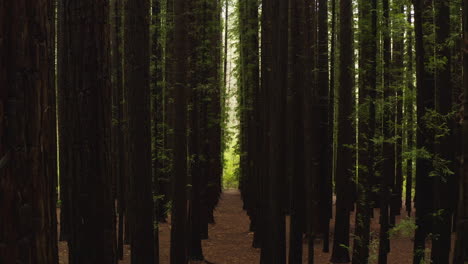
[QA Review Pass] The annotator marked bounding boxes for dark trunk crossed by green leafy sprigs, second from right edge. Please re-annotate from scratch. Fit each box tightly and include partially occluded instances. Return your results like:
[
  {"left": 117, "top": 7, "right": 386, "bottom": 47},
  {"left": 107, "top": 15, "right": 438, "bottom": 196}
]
[{"left": 431, "top": 0, "right": 456, "bottom": 264}]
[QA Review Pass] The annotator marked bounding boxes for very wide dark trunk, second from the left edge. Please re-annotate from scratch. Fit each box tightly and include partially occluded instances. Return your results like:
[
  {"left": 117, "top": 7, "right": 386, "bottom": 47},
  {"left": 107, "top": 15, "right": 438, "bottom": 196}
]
[{"left": 58, "top": 0, "right": 115, "bottom": 263}]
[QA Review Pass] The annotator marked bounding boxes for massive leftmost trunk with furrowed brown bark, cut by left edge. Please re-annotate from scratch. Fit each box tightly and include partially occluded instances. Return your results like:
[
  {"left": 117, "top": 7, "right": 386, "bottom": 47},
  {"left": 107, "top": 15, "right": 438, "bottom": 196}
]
[{"left": 0, "top": 1, "right": 58, "bottom": 264}]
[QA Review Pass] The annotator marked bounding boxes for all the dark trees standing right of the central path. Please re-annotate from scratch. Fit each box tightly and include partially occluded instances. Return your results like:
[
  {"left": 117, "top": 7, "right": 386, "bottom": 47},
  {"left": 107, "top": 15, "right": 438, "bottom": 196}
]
[{"left": 237, "top": 0, "right": 467, "bottom": 264}]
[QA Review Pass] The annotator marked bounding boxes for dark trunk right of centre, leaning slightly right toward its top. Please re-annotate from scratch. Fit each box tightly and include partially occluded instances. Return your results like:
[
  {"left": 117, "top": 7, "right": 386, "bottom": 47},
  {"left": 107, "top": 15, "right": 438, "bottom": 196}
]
[{"left": 331, "top": 0, "right": 355, "bottom": 263}]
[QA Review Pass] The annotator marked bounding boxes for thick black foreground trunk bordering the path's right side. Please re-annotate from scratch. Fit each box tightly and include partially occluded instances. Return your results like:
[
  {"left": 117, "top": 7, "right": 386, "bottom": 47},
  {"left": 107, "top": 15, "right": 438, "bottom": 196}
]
[{"left": 261, "top": 0, "right": 288, "bottom": 264}]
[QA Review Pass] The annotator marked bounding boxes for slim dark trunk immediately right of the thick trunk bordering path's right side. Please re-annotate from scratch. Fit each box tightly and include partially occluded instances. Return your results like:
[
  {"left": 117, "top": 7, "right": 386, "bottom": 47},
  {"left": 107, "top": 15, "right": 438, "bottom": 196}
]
[{"left": 289, "top": 0, "right": 310, "bottom": 263}]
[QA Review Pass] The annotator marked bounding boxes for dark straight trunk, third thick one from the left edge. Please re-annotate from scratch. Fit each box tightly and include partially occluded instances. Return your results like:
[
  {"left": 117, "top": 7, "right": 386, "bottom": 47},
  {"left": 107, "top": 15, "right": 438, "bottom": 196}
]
[{"left": 124, "top": 0, "right": 155, "bottom": 264}]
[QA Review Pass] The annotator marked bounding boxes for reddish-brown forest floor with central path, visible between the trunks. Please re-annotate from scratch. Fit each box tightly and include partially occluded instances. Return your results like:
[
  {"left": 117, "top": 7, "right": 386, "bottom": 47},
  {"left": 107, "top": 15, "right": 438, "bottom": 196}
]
[{"left": 59, "top": 190, "right": 452, "bottom": 264}]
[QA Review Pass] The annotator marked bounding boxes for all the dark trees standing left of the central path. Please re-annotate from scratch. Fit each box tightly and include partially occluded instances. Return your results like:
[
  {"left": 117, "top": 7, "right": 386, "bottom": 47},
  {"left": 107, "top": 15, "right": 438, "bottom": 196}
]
[{"left": 0, "top": 0, "right": 223, "bottom": 264}]
